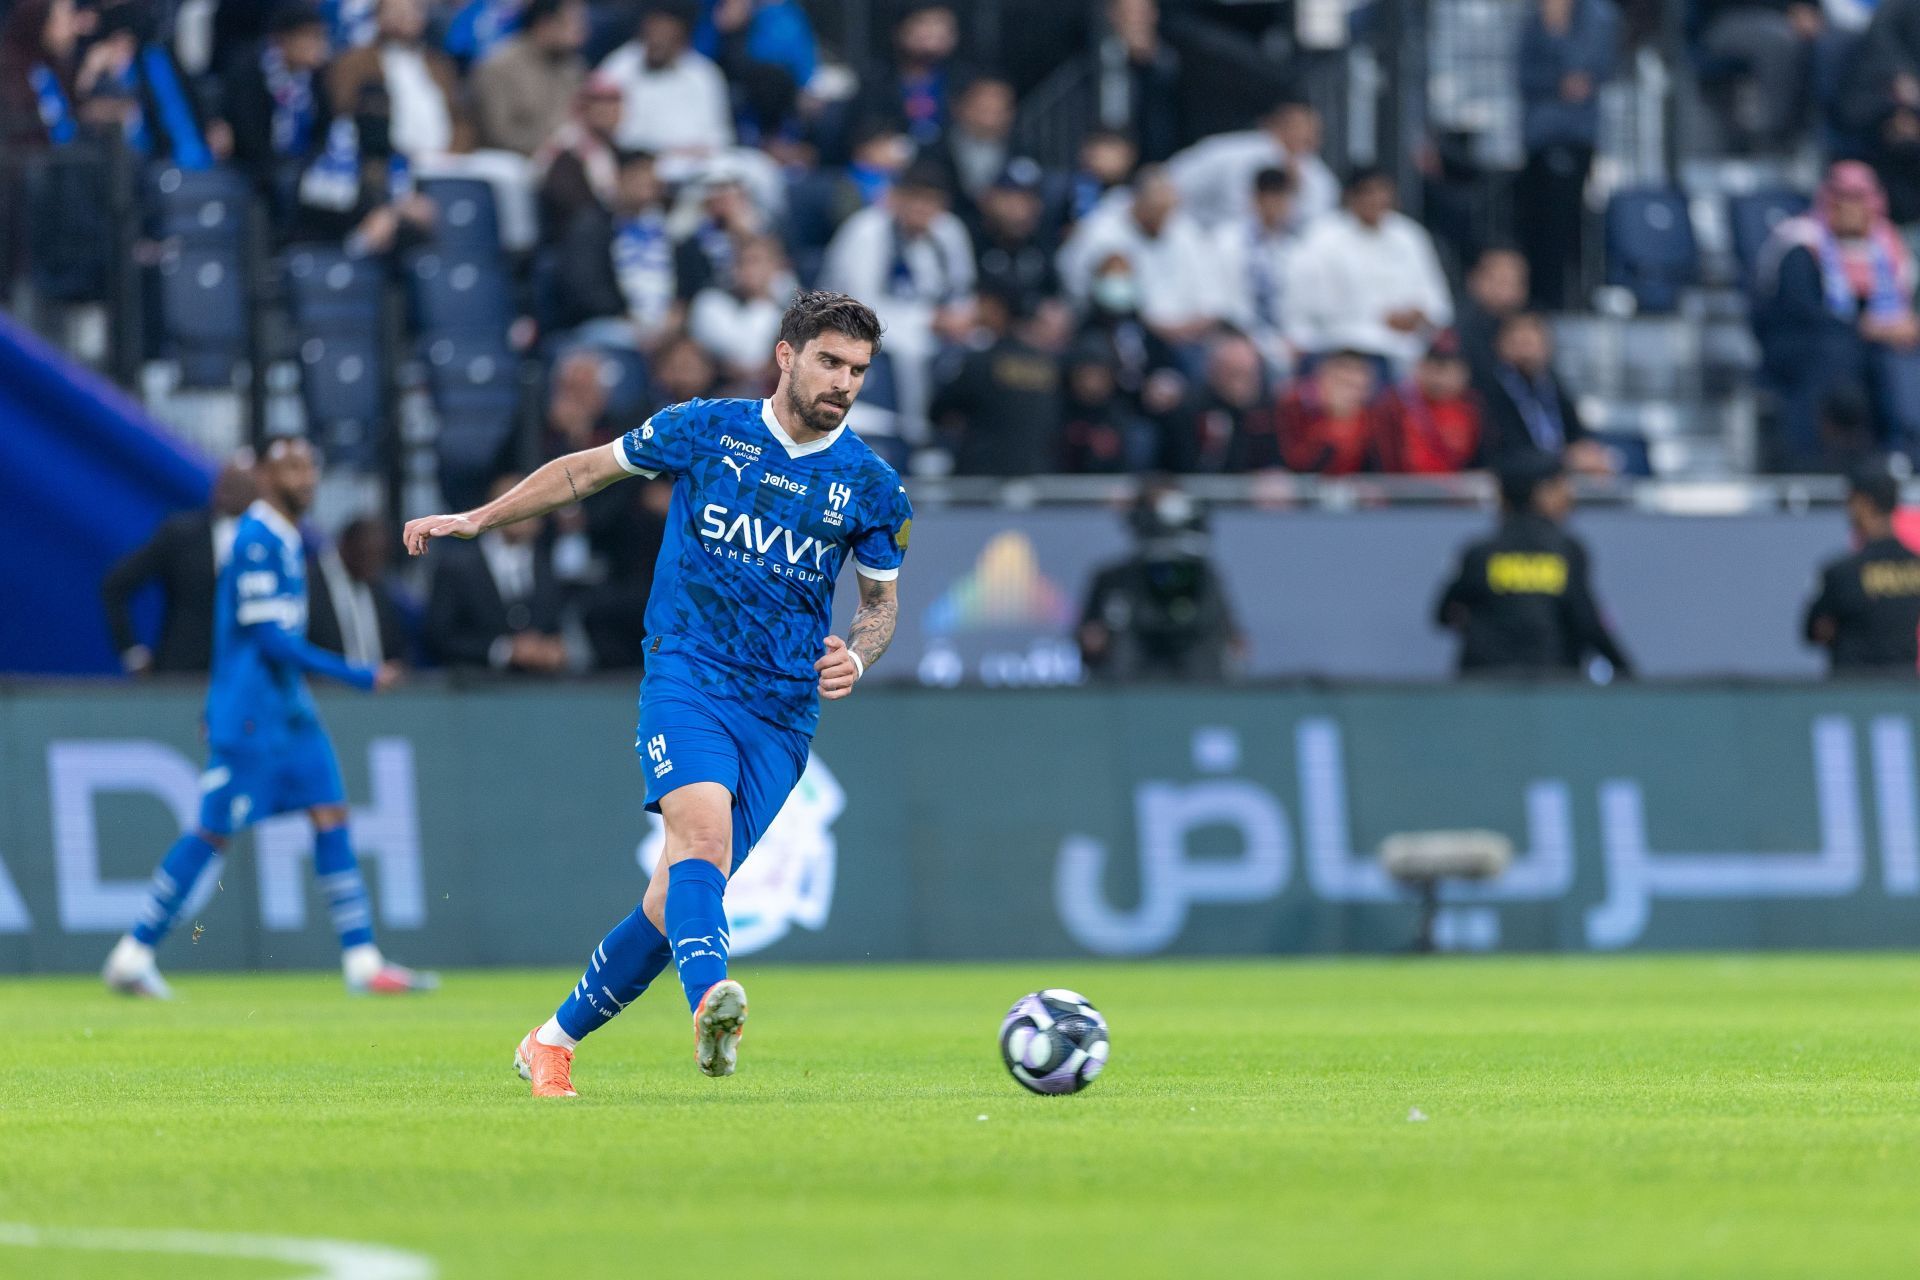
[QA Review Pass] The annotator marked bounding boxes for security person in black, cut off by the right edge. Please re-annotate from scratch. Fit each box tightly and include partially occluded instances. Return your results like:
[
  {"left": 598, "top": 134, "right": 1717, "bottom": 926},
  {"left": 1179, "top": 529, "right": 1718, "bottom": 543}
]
[{"left": 1807, "top": 470, "right": 1920, "bottom": 679}]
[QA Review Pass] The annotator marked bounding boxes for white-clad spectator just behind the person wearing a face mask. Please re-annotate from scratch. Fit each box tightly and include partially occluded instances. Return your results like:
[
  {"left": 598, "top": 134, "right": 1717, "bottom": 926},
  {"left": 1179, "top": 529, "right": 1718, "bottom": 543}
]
[{"left": 1060, "top": 165, "right": 1227, "bottom": 347}]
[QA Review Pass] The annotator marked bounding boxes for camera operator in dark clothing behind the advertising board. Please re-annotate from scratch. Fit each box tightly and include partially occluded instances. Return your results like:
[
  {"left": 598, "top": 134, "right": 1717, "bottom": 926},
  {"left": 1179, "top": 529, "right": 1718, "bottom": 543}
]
[{"left": 1079, "top": 484, "right": 1244, "bottom": 681}]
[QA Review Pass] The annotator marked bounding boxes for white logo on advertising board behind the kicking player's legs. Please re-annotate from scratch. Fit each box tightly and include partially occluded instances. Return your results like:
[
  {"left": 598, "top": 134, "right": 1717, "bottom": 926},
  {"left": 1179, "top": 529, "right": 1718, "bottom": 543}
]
[{"left": 637, "top": 756, "right": 847, "bottom": 956}]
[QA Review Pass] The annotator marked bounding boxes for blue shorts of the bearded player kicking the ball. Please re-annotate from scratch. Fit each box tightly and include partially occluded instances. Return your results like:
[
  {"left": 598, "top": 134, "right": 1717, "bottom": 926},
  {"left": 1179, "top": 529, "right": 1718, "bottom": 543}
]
[{"left": 634, "top": 672, "right": 810, "bottom": 871}]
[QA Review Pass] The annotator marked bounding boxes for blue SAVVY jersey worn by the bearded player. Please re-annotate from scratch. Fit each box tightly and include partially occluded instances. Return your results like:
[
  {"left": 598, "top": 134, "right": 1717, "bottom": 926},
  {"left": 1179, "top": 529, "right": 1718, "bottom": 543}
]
[{"left": 612, "top": 399, "right": 914, "bottom": 733}]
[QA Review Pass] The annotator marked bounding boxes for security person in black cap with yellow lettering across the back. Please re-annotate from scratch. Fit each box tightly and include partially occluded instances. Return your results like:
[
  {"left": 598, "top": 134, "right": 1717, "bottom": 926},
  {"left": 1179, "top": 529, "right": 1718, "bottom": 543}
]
[{"left": 1436, "top": 453, "right": 1634, "bottom": 676}]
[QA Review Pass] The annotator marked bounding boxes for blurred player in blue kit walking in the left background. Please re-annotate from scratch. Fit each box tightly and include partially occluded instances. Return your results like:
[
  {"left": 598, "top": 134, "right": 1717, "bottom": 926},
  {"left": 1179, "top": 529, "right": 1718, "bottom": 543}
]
[{"left": 102, "top": 438, "right": 438, "bottom": 1000}]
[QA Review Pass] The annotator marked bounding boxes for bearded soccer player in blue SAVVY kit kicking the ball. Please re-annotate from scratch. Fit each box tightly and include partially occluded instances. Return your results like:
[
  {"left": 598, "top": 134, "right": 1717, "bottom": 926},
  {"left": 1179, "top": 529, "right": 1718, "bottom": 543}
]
[{"left": 405, "top": 292, "right": 912, "bottom": 1098}]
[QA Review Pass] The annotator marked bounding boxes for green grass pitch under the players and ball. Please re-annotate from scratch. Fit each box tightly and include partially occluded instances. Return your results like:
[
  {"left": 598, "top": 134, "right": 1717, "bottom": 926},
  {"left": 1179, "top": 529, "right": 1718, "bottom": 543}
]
[{"left": 0, "top": 956, "right": 1920, "bottom": 1280}]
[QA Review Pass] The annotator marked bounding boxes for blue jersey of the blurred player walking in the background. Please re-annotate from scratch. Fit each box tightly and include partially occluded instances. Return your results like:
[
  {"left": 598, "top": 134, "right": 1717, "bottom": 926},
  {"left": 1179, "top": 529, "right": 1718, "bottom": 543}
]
[{"left": 207, "top": 503, "right": 374, "bottom": 750}]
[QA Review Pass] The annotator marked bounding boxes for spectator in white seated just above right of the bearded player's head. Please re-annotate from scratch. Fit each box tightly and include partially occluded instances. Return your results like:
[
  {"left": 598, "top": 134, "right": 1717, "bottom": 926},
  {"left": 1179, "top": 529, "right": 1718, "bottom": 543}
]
[{"left": 820, "top": 163, "right": 975, "bottom": 439}]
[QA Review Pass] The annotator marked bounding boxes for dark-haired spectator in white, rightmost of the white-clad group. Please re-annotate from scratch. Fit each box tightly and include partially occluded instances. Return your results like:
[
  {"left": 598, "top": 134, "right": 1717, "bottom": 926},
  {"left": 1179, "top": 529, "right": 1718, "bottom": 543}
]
[{"left": 1286, "top": 169, "right": 1453, "bottom": 368}]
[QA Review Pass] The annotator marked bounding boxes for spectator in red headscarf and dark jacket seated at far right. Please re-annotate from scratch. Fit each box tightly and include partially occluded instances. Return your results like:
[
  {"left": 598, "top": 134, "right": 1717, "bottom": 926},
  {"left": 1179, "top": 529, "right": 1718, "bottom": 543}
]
[{"left": 1753, "top": 161, "right": 1920, "bottom": 466}]
